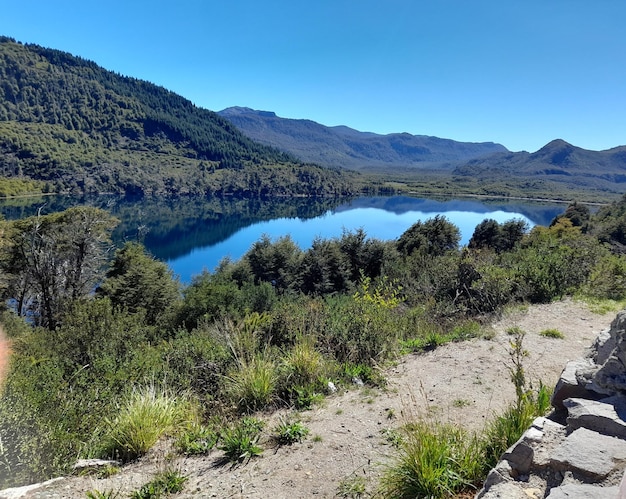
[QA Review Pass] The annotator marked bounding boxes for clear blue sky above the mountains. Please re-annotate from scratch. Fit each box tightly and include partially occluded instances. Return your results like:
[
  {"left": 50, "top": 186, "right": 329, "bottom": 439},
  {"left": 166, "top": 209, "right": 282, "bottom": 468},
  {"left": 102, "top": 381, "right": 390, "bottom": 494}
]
[{"left": 0, "top": 0, "right": 626, "bottom": 151}]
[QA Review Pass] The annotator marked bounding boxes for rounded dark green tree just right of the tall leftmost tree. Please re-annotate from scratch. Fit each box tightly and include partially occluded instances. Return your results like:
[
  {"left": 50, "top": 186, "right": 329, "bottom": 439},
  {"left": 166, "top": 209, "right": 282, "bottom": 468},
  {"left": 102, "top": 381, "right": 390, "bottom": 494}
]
[{"left": 98, "top": 243, "right": 180, "bottom": 325}]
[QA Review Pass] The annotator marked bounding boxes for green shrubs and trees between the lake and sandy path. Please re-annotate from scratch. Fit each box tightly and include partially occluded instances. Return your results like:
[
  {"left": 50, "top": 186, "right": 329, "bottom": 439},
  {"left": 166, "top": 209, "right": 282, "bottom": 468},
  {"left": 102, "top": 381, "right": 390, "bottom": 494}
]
[{"left": 0, "top": 196, "right": 626, "bottom": 496}]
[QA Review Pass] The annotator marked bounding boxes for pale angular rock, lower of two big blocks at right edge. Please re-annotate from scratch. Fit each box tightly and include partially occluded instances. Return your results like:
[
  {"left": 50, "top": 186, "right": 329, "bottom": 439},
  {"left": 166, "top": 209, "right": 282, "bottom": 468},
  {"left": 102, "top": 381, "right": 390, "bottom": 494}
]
[{"left": 550, "top": 428, "right": 626, "bottom": 481}]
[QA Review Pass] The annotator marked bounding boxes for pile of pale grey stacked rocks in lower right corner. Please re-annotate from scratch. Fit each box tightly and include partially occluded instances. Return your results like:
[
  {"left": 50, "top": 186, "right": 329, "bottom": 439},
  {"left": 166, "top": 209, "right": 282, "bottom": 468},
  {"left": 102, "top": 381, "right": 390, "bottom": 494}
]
[{"left": 476, "top": 311, "right": 626, "bottom": 499}]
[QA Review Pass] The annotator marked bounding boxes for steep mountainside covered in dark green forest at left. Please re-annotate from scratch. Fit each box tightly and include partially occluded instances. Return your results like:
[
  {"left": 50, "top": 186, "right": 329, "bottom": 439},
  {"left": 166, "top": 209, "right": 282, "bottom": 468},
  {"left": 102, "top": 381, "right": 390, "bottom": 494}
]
[{"left": 0, "top": 37, "right": 356, "bottom": 196}]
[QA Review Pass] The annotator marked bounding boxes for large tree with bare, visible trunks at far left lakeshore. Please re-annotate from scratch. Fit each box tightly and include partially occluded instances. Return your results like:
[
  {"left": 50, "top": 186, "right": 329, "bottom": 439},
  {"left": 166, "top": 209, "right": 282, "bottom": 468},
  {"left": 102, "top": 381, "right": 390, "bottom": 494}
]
[{"left": 3, "top": 207, "right": 117, "bottom": 329}]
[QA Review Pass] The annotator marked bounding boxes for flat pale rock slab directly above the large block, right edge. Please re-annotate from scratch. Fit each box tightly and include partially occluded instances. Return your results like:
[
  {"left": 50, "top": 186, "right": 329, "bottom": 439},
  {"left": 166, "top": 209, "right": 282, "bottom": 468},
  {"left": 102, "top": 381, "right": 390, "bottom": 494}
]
[{"left": 563, "top": 395, "right": 626, "bottom": 438}]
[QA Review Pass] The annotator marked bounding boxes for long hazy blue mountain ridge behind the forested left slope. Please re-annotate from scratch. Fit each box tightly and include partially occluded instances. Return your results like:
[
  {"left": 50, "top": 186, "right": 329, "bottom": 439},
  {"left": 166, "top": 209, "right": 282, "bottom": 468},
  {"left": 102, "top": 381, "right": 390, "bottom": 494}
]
[{"left": 218, "top": 107, "right": 507, "bottom": 169}]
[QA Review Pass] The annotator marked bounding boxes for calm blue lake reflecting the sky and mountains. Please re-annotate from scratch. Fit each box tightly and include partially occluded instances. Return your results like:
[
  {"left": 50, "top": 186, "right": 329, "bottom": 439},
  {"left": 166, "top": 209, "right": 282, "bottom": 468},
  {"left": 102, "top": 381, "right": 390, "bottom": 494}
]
[{"left": 0, "top": 196, "right": 566, "bottom": 283}]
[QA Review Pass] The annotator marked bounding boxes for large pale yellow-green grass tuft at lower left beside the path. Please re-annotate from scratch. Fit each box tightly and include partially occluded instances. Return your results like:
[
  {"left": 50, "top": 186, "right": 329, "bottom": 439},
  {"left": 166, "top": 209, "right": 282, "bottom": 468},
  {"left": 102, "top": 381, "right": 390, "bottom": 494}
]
[{"left": 95, "top": 385, "right": 196, "bottom": 461}]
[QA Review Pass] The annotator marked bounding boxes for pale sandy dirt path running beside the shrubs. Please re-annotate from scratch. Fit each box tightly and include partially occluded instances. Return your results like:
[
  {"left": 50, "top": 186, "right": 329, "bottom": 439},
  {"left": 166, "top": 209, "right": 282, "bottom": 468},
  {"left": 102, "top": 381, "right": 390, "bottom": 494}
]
[{"left": 0, "top": 300, "right": 615, "bottom": 499}]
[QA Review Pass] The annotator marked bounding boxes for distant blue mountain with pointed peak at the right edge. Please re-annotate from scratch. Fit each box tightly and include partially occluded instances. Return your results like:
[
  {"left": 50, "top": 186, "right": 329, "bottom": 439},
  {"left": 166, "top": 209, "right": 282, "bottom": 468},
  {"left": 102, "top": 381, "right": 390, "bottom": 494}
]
[{"left": 453, "top": 139, "right": 626, "bottom": 193}]
